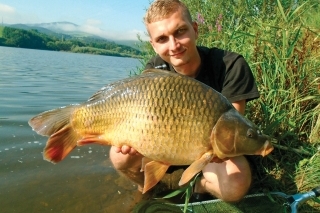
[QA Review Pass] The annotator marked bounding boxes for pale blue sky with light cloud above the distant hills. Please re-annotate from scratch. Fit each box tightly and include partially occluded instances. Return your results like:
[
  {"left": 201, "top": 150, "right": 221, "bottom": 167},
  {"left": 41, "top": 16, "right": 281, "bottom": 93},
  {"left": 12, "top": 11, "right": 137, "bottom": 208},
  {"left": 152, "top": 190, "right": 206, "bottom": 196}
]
[{"left": 0, "top": 0, "right": 150, "bottom": 40}]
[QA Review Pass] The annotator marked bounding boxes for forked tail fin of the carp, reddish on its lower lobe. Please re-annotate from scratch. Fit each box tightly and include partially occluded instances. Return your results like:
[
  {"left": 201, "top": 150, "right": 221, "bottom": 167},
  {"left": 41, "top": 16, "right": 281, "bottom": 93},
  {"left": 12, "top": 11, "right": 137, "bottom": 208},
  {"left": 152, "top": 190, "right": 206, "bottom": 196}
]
[{"left": 29, "top": 105, "right": 80, "bottom": 163}]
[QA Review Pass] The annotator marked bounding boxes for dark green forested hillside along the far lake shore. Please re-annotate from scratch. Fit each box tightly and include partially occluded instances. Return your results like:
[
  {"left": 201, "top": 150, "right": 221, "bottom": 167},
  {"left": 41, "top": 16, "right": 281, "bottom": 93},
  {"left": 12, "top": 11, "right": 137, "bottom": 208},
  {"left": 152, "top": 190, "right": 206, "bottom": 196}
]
[{"left": 0, "top": 26, "right": 140, "bottom": 58}]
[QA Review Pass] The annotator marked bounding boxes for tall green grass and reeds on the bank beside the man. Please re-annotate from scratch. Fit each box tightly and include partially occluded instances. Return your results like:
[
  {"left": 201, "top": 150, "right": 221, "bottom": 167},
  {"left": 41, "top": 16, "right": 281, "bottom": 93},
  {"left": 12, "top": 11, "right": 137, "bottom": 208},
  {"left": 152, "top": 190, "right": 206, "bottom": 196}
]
[{"left": 141, "top": 0, "right": 320, "bottom": 203}]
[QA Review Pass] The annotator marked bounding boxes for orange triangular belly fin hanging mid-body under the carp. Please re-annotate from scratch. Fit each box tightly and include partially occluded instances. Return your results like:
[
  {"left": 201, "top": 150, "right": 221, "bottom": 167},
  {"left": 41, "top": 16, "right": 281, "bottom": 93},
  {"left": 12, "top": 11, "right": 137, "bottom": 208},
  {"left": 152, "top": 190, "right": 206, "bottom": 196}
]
[{"left": 142, "top": 161, "right": 170, "bottom": 194}]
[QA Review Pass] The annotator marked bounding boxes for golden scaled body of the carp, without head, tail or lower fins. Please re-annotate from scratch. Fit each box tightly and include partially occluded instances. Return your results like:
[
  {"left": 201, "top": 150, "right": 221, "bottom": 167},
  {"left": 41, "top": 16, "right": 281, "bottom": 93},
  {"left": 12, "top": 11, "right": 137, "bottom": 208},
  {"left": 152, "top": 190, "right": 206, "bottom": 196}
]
[{"left": 74, "top": 73, "right": 232, "bottom": 165}]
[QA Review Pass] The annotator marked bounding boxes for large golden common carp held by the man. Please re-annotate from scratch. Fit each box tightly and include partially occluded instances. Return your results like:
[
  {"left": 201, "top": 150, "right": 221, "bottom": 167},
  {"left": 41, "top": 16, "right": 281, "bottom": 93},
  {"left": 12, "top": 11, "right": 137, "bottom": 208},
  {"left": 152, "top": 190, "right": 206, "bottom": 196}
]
[{"left": 29, "top": 69, "right": 273, "bottom": 192}]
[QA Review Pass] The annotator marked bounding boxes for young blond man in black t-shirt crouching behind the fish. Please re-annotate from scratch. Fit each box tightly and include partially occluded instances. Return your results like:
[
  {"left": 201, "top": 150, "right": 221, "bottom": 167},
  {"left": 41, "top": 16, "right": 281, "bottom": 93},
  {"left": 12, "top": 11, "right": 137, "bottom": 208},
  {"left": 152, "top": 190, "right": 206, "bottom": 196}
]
[{"left": 110, "top": 0, "right": 259, "bottom": 202}]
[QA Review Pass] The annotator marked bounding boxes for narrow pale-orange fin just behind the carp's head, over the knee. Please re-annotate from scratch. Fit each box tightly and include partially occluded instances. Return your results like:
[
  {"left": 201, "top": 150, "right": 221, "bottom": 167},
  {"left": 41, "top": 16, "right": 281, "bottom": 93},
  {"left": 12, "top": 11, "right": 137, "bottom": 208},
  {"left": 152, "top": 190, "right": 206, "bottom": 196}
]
[{"left": 179, "top": 151, "right": 214, "bottom": 186}]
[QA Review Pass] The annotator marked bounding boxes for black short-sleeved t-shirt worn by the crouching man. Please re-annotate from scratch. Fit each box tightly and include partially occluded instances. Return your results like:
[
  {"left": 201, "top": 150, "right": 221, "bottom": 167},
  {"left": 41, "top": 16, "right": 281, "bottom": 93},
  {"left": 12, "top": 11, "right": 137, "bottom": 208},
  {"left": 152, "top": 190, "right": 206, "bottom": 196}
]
[{"left": 145, "top": 47, "right": 259, "bottom": 103}]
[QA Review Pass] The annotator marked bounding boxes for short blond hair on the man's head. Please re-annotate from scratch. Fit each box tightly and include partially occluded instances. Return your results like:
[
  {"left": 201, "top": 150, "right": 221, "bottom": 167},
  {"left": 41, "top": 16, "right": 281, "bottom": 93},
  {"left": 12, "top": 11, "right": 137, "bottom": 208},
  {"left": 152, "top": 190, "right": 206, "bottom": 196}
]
[{"left": 144, "top": 0, "right": 192, "bottom": 26}]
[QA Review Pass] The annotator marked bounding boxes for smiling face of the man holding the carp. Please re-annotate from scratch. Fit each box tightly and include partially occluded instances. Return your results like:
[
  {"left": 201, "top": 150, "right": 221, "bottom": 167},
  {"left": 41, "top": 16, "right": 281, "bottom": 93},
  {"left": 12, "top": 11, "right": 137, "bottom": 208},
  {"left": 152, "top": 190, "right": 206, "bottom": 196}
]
[{"left": 147, "top": 10, "right": 198, "bottom": 69}]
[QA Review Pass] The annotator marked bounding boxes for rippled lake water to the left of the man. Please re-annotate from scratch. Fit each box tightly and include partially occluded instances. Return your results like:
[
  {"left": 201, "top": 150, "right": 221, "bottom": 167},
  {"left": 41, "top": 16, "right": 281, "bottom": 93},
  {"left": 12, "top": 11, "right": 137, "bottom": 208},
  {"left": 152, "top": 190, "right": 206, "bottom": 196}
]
[{"left": 0, "top": 47, "right": 148, "bottom": 213}]
